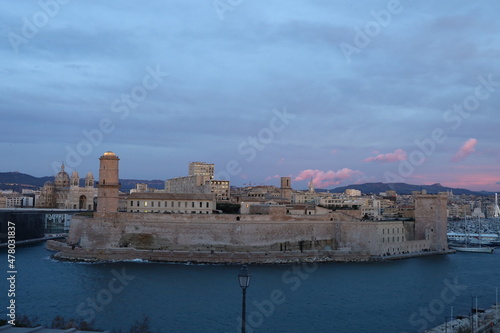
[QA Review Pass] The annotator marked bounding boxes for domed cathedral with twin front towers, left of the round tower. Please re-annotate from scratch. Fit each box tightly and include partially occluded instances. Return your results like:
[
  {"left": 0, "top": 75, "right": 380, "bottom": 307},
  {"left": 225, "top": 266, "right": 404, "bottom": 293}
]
[{"left": 36, "top": 163, "right": 97, "bottom": 210}]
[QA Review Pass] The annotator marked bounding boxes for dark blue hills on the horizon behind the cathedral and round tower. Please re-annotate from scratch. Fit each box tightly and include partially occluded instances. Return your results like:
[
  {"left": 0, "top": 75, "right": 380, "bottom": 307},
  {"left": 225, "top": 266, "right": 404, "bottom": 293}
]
[{"left": 0, "top": 172, "right": 165, "bottom": 192}]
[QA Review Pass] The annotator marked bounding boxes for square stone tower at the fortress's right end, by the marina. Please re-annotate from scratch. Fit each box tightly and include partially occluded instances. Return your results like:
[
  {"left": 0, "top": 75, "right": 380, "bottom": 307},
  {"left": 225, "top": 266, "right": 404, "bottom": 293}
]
[{"left": 415, "top": 194, "right": 448, "bottom": 251}]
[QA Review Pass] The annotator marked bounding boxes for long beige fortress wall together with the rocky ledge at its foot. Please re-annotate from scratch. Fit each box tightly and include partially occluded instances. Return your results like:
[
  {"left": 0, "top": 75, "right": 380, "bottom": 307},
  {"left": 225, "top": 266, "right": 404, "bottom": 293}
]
[{"left": 48, "top": 211, "right": 452, "bottom": 262}]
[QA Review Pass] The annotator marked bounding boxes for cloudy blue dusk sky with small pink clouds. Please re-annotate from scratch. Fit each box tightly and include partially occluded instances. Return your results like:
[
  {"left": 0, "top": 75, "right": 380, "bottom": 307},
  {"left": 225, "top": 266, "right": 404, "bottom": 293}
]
[{"left": 0, "top": 0, "right": 500, "bottom": 191}]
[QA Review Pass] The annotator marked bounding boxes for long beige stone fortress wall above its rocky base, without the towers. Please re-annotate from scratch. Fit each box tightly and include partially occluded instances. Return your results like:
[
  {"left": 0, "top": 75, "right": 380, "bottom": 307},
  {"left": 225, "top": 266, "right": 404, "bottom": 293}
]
[{"left": 68, "top": 211, "right": 438, "bottom": 256}]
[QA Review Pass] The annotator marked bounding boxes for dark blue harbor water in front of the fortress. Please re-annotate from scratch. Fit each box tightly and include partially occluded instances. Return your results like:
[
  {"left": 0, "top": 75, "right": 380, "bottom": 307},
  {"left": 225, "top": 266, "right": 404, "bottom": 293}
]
[{"left": 0, "top": 243, "right": 500, "bottom": 333}]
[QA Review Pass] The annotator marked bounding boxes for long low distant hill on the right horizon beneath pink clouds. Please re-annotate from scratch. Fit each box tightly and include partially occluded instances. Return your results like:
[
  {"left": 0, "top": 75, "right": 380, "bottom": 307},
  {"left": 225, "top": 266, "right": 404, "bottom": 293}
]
[{"left": 330, "top": 183, "right": 493, "bottom": 195}]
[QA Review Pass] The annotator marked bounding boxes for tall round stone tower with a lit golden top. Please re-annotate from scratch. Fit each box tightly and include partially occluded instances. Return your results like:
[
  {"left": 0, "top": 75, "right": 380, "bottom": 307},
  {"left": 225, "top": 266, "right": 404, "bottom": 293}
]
[{"left": 97, "top": 151, "right": 120, "bottom": 214}]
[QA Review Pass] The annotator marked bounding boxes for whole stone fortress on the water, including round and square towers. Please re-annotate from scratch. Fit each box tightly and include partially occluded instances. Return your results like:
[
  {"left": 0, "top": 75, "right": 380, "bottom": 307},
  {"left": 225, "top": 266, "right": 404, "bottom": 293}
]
[{"left": 47, "top": 152, "right": 450, "bottom": 263}]
